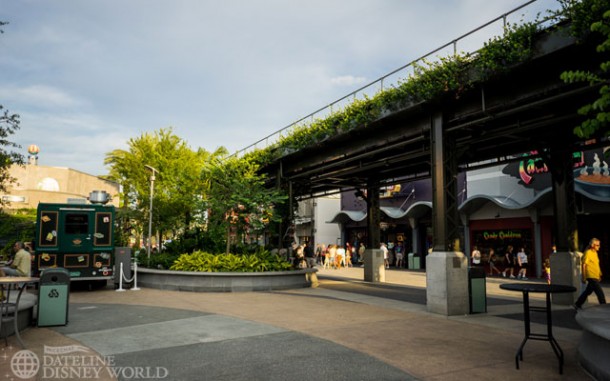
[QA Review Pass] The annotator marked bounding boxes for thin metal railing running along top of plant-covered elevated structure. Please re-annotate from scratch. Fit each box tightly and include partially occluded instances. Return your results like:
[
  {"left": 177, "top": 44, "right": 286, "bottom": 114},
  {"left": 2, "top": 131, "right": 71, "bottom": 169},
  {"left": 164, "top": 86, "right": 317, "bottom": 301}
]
[{"left": 231, "top": 0, "right": 558, "bottom": 156}]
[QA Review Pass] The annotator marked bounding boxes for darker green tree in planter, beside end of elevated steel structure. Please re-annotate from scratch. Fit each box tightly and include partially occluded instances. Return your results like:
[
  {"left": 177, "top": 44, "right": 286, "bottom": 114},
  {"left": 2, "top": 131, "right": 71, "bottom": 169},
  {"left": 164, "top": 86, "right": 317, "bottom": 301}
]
[{"left": 202, "top": 156, "right": 286, "bottom": 254}]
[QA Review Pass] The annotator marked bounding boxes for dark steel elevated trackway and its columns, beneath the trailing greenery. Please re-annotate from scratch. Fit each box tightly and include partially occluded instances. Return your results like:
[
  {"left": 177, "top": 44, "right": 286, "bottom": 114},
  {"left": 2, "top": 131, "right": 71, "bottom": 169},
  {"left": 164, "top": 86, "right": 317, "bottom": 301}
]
[{"left": 258, "top": 20, "right": 606, "bottom": 315}]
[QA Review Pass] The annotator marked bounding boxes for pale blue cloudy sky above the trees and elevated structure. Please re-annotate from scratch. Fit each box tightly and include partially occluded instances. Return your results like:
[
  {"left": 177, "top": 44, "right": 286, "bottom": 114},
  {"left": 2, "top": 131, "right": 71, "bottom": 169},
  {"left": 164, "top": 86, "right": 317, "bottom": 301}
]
[{"left": 0, "top": 0, "right": 559, "bottom": 175}]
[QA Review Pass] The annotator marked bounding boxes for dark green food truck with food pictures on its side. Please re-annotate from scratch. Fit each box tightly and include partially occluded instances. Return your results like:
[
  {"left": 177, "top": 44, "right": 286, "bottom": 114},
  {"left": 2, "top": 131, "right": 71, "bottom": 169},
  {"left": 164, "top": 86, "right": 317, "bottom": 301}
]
[{"left": 32, "top": 191, "right": 115, "bottom": 282}]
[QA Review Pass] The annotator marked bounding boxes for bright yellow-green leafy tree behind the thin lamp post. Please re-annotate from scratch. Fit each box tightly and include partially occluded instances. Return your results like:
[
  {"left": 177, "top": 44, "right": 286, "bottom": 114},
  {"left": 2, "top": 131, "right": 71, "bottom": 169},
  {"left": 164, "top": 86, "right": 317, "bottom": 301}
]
[{"left": 104, "top": 128, "right": 216, "bottom": 246}]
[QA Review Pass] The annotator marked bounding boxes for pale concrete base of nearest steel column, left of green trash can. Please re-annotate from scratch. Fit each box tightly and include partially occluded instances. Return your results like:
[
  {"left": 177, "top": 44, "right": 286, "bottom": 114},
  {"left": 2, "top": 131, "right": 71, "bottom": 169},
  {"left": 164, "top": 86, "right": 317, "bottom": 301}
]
[{"left": 426, "top": 251, "right": 470, "bottom": 316}]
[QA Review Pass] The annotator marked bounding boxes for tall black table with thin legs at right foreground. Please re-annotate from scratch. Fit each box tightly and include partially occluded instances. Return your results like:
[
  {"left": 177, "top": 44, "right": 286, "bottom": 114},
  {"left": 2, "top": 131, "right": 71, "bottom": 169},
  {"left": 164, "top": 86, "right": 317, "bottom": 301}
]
[{"left": 500, "top": 283, "right": 576, "bottom": 374}]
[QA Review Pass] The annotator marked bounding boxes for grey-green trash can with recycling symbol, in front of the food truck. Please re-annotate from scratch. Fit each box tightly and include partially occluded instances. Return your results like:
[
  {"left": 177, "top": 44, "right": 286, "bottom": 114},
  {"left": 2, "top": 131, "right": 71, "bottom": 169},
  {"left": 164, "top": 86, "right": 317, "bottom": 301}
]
[{"left": 38, "top": 268, "right": 70, "bottom": 327}]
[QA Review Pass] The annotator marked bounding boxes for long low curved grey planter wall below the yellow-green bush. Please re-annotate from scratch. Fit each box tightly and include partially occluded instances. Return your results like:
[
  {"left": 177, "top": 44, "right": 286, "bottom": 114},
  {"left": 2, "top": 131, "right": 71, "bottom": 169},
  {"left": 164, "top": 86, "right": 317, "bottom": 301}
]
[{"left": 138, "top": 267, "right": 318, "bottom": 292}]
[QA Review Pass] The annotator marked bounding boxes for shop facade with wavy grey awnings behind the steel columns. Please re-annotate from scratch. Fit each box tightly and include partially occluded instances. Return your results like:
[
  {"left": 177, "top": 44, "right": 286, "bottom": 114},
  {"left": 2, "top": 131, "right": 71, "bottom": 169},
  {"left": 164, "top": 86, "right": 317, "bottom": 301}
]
[{"left": 332, "top": 148, "right": 610, "bottom": 277}]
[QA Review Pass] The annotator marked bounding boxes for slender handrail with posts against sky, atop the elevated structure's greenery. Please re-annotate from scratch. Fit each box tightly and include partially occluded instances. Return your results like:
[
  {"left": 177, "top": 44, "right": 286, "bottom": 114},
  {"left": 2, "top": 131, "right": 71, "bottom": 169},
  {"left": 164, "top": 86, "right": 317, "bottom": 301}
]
[{"left": 230, "top": 0, "right": 560, "bottom": 157}]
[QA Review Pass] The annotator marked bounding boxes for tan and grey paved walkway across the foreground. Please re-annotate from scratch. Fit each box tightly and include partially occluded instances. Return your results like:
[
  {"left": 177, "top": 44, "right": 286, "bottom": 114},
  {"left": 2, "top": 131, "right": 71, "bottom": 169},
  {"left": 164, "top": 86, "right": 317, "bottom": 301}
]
[{"left": 0, "top": 268, "right": 610, "bottom": 381}]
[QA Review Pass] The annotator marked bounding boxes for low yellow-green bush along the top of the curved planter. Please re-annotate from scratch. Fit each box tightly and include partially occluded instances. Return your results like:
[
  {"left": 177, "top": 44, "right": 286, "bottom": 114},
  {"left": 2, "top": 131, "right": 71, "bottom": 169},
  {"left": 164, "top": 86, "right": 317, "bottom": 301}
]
[{"left": 170, "top": 251, "right": 292, "bottom": 272}]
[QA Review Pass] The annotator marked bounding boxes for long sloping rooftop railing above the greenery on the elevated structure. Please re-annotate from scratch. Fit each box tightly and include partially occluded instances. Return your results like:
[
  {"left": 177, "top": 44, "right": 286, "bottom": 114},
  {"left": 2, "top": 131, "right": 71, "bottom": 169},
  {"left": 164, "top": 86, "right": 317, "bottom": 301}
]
[{"left": 231, "top": 0, "right": 559, "bottom": 156}]
